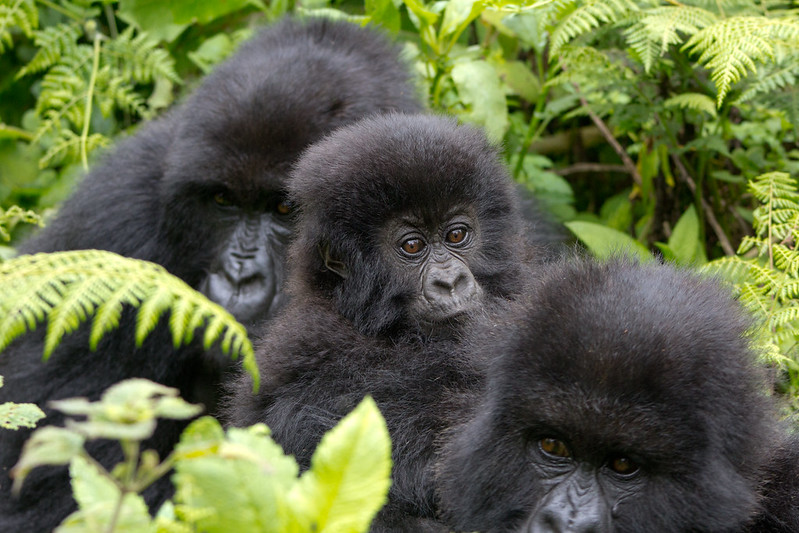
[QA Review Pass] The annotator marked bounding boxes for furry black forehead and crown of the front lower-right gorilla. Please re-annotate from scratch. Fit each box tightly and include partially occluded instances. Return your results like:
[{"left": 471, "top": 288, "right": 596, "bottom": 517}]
[{"left": 492, "top": 260, "right": 762, "bottom": 440}]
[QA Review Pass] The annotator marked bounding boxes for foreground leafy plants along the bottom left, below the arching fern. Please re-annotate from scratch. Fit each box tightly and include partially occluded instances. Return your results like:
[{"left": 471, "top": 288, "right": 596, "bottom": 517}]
[{"left": 13, "top": 379, "right": 391, "bottom": 533}]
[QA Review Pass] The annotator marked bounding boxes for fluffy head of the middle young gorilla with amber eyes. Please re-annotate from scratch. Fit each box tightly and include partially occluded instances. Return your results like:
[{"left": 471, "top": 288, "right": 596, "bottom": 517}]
[{"left": 289, "top": 115, "right": 522, "bottom": 335}]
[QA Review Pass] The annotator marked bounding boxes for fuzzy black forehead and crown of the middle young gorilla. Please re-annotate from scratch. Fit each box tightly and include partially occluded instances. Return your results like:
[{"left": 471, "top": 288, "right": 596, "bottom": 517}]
[{"left": 289, "top": 114, "right": 515, "bottom": 232}]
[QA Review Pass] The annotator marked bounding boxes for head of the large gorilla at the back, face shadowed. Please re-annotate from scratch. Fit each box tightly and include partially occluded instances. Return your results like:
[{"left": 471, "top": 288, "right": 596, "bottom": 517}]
[{"left": 155, "top": 19, "right": 420, "bottom": 322}]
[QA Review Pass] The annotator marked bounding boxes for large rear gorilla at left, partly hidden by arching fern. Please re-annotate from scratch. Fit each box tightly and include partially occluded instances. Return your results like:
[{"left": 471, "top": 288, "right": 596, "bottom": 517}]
[{"left": 0, "top": 19, "right": 421, "bottom": 531}]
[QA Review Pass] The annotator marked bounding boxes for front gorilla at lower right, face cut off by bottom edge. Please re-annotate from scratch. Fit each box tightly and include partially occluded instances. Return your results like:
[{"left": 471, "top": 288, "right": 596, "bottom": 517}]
[{"left": 437, "top": 260, "right": 799, "bottom": 533}]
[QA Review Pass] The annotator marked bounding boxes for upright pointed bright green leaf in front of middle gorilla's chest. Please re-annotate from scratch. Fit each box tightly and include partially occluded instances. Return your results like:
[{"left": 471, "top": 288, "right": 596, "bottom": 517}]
[{"left": 289, "top": 397, "right": 391, "bottom": 533}]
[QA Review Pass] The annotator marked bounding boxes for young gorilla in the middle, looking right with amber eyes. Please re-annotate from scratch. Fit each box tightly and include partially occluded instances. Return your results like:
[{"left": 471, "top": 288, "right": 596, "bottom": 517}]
[{"left": 225, "top": 114, "right": 564, "bottom": 531}]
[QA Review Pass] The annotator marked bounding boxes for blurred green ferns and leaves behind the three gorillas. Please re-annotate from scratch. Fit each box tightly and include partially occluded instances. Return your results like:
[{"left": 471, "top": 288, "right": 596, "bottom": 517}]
[{"left": 0, "top": 0, "right": 799, "bottom": 408}]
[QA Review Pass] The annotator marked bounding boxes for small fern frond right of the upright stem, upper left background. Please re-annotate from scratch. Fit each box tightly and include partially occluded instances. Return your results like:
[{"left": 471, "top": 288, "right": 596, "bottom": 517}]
[{"left": 102, "top": 26, "right": 181, "bottom": 83}]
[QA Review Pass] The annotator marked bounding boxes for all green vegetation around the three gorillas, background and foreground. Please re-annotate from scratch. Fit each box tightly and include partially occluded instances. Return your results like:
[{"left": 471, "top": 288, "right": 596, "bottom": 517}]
[{"left": 0, "top": 0, "right": 799, "bottom": 531}]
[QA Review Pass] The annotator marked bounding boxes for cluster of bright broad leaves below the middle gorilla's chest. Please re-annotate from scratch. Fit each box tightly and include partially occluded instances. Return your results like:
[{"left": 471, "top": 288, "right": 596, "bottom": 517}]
[{"left": 174, "top": 398, "right": 391, "bottom": 533}]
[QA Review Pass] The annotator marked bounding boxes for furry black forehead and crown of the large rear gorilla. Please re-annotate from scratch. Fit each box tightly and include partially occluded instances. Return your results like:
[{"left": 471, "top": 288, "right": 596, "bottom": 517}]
[{"left": 165, "top": 19, "right": 420, "bottom": 203}]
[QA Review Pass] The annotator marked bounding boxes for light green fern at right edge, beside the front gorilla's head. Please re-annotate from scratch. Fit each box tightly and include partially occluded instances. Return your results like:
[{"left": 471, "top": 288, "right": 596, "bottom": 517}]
[{"left": 707, "top": 172, "right": 799, "bottom": 407}]
